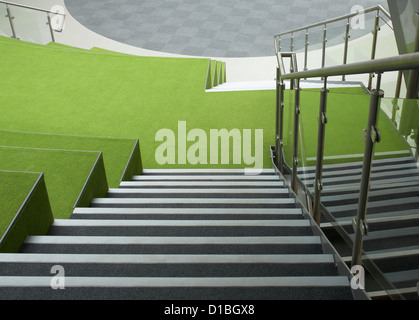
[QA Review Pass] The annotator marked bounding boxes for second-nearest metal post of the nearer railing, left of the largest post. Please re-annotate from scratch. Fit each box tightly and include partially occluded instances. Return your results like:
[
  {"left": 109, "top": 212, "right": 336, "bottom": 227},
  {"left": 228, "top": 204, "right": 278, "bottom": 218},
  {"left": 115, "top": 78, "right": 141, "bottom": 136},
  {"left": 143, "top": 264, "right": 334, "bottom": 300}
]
[{"left": 313, "top": 77, "right": 329, "bottom": 225}]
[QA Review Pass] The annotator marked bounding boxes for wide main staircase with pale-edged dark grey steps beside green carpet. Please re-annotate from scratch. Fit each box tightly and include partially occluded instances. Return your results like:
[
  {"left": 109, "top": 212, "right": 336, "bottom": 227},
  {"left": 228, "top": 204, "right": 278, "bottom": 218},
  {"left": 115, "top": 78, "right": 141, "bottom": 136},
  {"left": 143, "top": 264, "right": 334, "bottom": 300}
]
[{"left": 0, "top": 170, "right": 353, "bottom": 300}]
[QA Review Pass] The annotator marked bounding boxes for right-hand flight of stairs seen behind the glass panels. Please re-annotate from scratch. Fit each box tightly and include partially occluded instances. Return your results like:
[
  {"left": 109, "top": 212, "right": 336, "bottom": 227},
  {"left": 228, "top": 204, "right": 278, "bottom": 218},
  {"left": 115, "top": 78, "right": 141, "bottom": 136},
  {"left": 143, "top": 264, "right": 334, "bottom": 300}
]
[{"left": 301, "top": 157, "right": 419, "bottom": 299}]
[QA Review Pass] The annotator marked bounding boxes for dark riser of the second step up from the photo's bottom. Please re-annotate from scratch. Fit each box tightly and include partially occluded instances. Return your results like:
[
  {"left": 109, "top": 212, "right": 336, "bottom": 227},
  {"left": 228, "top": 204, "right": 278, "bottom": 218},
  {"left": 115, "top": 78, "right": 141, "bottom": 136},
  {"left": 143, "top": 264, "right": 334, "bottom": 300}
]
[{"left": 0, "top": 263, "right": 336, "bottom": 277}]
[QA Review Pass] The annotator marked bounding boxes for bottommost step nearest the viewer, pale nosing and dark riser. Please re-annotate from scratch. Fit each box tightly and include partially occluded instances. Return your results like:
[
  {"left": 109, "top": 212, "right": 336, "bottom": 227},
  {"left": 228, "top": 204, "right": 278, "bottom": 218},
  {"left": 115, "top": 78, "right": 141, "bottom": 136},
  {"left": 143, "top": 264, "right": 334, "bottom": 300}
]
[{"left": 0, "top": 276, "right": 353, "bottom": 300}]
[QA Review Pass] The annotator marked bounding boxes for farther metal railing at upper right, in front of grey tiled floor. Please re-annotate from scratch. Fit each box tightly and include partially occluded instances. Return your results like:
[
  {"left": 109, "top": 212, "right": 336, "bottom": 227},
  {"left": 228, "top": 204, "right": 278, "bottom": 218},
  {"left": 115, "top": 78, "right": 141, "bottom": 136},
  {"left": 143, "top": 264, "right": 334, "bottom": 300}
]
[{"left": 274, "top": 5, "right": 391, "bottom": 85}]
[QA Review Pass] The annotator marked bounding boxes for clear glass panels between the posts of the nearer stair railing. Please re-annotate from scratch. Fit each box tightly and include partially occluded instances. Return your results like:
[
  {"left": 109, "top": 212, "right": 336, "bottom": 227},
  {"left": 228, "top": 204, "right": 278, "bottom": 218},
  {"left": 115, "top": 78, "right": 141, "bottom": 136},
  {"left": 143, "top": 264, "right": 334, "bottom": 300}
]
[{"left": 283, "top": 80, "right": 419, "bottom": 299}]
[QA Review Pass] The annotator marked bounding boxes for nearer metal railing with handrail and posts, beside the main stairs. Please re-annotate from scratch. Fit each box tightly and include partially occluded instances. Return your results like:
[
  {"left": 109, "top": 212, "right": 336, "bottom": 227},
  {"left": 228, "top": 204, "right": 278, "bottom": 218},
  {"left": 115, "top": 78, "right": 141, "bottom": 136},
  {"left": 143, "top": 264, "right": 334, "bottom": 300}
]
[{"left": 274, "top": 53, "right": 419, "bottom": 298}]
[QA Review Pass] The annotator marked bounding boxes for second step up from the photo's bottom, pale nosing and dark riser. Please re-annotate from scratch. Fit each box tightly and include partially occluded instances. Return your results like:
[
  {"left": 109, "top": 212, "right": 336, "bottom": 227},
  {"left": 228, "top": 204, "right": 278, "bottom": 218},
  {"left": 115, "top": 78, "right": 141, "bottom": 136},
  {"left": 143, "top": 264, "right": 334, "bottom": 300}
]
[{"left": 0, "top": 254, "right": 336, "bottom": 277}]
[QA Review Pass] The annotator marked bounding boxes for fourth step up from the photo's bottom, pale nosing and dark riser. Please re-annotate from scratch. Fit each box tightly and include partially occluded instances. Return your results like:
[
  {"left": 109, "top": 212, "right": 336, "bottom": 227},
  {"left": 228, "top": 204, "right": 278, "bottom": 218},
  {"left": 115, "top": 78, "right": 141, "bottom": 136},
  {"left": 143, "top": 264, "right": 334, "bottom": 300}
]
[{"left": 49, "top": 219, "right": 311, "bottom": 237}]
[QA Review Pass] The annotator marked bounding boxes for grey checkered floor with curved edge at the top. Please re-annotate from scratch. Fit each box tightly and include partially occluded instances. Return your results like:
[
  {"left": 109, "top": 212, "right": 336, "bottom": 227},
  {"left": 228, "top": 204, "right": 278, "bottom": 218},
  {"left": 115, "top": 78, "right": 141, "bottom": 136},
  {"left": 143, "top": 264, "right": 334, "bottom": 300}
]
[{"left": 65, "top": 0, "right": 388, "bottom": 57}]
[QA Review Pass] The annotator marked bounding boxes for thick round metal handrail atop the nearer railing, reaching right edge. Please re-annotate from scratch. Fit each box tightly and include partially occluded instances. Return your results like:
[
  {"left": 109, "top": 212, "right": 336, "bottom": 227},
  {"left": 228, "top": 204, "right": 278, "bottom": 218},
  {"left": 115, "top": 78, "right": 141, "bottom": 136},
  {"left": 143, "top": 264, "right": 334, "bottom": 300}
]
[{"left": 281, "top": 52, "right": 419, "bottom": 80}]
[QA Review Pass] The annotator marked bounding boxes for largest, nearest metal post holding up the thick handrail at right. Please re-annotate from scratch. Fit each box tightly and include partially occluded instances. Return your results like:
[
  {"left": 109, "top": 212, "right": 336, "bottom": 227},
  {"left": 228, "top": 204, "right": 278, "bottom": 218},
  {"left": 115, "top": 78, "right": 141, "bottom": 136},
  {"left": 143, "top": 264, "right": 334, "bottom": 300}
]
[{"left": 352, "top": 73, "right": 384, "bottom": 266}]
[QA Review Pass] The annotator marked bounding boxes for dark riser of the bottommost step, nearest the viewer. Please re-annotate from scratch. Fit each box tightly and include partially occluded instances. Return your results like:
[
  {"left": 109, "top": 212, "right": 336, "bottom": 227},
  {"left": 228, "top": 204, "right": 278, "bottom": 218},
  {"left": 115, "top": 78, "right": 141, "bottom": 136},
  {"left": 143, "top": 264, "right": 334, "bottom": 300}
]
[{"left": 0, "top": 286, "right": 352, "bottom": 302}]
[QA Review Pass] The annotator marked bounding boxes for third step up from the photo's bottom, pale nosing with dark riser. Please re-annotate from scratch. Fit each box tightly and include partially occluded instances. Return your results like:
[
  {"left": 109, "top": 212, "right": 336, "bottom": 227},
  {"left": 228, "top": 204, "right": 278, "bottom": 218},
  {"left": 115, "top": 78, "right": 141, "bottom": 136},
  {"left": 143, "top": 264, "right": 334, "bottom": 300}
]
[{"left": 21, "top": 235, "right": 323, "bottom": 255}]
